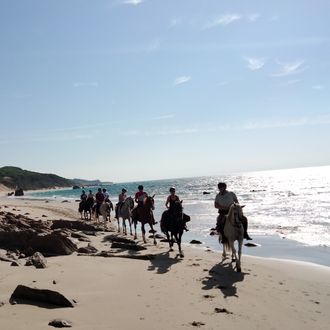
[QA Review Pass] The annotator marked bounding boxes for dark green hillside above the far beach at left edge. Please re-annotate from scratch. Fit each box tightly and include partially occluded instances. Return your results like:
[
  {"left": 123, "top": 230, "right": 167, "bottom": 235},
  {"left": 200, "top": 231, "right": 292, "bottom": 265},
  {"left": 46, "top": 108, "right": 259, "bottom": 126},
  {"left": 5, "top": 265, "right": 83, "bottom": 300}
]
[{"left": 0, "top": 166, "right": 74, "bottom": 190}]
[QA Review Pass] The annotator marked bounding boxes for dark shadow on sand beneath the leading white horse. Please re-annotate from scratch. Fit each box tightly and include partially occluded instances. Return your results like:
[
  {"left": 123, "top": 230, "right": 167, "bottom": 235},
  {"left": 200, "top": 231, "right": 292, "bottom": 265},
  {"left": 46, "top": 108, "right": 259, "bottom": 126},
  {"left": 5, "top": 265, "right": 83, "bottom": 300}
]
[{"left": 202, "top": 259, "right": 249, "bottom": 298}]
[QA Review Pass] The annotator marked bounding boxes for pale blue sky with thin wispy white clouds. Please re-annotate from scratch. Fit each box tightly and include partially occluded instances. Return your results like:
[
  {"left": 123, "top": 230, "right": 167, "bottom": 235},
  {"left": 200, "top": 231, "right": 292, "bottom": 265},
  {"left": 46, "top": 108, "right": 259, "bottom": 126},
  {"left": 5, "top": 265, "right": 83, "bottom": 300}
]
[{"left": 0, "top": 0, "right": 330, "bottom": 182}]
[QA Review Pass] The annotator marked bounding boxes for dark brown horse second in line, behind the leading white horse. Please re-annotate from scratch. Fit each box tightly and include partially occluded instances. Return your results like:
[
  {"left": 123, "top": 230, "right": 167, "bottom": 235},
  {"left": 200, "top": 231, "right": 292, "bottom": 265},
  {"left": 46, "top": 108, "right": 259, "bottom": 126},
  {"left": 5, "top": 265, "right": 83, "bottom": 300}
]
[{"left": 160, "top": 201, "right": 190, "bottom": 258}]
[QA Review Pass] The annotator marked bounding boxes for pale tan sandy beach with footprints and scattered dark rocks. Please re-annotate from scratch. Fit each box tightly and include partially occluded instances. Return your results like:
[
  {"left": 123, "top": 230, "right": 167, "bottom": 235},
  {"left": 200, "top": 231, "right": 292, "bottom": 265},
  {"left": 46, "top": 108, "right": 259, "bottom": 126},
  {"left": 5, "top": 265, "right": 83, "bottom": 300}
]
[{"left": 0, "top": 192, "right": 330, "bottom": 330}]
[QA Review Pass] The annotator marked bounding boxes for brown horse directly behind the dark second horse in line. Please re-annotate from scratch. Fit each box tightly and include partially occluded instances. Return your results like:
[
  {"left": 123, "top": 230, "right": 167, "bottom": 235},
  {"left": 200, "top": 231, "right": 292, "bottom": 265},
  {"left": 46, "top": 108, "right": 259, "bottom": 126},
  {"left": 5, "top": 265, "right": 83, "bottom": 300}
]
[{"left": 132, "top": 195, "right": 157, "bottom": 245}]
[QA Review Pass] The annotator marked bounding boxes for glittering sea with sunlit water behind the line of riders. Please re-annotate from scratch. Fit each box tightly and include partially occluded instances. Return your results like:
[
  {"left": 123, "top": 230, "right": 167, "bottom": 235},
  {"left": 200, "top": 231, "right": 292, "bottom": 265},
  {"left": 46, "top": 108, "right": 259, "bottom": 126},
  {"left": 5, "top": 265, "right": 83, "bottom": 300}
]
[{"left": 27, "top": 166, "right": 330, "bottom": 266}]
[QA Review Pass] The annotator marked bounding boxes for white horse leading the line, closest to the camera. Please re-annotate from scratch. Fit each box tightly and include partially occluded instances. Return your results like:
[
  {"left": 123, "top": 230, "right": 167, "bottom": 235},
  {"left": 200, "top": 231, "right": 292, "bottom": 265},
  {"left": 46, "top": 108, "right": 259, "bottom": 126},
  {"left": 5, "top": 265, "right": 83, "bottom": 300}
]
[{"left": 219, "top": 203, "right": 244, "bottom": 273}]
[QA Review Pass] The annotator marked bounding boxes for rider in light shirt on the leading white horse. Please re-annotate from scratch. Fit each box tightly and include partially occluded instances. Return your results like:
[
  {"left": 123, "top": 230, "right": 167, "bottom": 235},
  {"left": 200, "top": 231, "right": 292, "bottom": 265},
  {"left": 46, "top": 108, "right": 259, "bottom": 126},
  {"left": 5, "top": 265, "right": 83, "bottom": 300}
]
[{"left": 214, "top": 182, "right": 252, "bottom": 240}]
